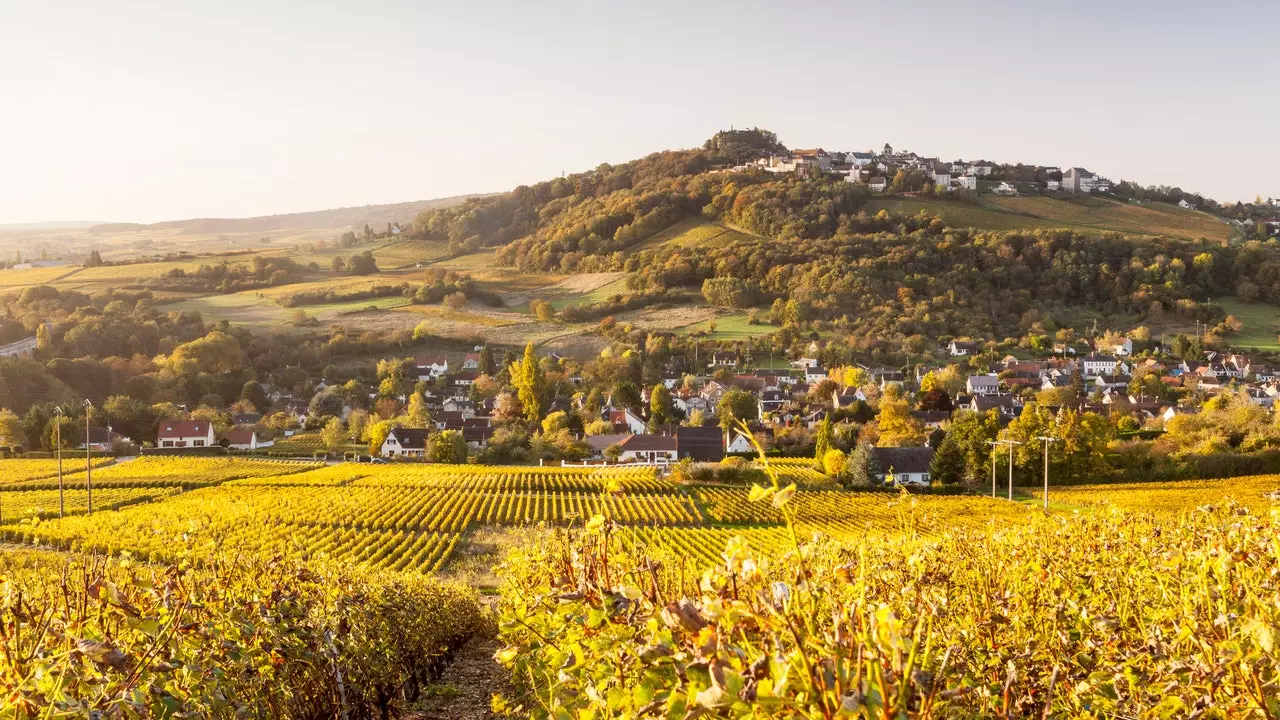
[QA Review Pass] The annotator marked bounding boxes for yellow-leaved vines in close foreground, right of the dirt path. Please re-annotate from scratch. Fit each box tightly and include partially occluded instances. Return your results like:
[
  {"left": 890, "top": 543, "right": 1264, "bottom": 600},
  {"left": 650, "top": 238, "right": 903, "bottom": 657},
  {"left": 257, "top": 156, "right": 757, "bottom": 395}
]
[{"left": 498, "top": 499, "right": 1280, "bottom": 717}]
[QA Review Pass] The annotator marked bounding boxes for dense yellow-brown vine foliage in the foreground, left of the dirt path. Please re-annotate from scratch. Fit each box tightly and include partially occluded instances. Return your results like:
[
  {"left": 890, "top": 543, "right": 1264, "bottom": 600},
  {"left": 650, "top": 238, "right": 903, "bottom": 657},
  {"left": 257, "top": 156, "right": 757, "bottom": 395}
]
[{"left": 0, "top": 551, "right": 484, "bottom": 719}]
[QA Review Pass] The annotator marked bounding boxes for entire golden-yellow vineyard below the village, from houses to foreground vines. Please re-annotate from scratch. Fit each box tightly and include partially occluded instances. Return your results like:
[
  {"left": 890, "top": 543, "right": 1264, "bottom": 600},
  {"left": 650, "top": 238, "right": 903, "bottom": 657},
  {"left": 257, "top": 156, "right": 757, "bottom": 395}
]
[{"left": 0, "top": 456, "right": 1280, "bottom": 717}]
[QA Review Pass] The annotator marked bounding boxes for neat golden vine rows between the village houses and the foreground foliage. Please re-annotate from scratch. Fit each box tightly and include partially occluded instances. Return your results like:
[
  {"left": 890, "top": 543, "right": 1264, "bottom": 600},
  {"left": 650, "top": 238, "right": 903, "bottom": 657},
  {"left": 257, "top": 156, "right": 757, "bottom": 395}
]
[{"left": 0, "top": 456, "right": 1280, "bottom": 573}]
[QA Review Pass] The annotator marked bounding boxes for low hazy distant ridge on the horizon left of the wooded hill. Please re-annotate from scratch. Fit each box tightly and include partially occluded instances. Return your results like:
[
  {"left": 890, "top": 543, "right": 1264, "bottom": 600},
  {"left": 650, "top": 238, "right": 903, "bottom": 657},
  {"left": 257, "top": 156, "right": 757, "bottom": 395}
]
[{"left": 86, "top": 195, "right": 483, "bottom": 234}]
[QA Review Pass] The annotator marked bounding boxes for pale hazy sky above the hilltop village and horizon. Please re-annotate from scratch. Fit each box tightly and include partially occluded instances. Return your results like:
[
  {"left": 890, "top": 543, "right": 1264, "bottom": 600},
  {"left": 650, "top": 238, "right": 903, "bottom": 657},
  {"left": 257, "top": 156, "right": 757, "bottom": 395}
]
[{"left": 0, "top": 0, "right": 1280, "bottom": 223}]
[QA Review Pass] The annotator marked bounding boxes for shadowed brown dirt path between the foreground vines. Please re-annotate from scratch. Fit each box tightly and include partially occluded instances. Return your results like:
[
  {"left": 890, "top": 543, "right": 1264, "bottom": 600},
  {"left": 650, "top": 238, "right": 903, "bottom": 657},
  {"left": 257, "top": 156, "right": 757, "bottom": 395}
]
[{"left": 410, "top": 635, "right": 511, "bottom": 720}]
